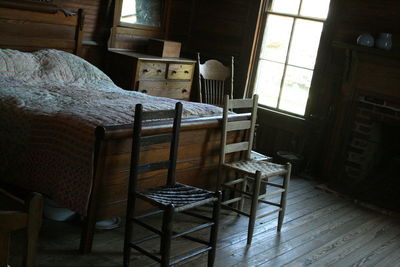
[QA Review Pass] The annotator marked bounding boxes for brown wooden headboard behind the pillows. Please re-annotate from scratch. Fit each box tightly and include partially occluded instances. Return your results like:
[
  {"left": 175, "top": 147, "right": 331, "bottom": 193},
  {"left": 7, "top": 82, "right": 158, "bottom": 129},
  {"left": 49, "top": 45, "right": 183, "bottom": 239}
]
[{"left": 0, "top": 0, "right": 84, "bottom": 55}]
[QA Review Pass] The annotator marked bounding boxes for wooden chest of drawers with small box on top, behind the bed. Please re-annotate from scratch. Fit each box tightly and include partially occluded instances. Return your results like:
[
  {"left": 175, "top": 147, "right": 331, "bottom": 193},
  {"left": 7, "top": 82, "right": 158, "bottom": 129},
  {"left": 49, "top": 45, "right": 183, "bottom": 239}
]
[{"left": 108, "top": 50, "right": 196, "bottom": 100}]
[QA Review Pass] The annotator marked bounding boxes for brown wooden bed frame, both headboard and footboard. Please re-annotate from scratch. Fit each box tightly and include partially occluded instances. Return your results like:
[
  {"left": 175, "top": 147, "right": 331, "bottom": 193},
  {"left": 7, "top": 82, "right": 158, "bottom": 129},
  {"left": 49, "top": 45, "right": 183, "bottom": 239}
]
[{"left": 0, "top": 0, "right": 246, "bottom": 253}]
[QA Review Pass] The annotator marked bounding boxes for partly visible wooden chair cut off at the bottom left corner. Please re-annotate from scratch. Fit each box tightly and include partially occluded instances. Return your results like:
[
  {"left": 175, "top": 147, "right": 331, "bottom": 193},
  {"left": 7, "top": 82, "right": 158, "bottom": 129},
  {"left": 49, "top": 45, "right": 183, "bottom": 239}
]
[{"left": 0, "top": 189, "right": 43, "bottom": 267}]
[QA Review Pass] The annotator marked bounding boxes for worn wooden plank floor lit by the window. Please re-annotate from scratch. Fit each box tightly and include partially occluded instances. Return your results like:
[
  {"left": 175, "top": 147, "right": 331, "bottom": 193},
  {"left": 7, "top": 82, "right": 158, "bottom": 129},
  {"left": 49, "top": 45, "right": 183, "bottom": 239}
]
[{"left": 12, "top": 178, "right": 400, "bottom": 267}]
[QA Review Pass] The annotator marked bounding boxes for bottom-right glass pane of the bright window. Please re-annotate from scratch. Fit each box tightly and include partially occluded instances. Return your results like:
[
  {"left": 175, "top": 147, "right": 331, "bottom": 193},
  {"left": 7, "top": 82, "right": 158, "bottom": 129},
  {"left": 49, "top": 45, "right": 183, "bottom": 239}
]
[{"left": 279, "top": 66, "right": 313, "bottom": 115}]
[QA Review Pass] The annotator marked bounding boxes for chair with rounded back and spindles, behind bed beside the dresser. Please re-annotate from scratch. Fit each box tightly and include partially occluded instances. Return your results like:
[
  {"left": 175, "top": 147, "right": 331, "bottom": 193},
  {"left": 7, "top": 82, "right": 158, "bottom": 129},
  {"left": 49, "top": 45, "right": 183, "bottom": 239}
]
[{"left": 197, "top": 53, "right": 234, "bottom": 106}]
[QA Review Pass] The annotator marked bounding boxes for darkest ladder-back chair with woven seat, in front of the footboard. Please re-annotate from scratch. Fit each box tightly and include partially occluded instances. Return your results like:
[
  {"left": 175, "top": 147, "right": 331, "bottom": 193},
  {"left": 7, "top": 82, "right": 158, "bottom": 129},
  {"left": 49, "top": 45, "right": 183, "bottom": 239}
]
[{"left": 124, "top": 102, "right": 221, "bottom": 266}]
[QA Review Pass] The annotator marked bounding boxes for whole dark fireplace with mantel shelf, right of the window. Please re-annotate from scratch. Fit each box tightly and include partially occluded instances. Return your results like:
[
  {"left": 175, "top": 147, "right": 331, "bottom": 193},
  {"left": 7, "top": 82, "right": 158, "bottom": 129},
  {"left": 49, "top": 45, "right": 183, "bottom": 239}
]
[{"left": 322, "top": 43, "right": 400, "bottom": 211}]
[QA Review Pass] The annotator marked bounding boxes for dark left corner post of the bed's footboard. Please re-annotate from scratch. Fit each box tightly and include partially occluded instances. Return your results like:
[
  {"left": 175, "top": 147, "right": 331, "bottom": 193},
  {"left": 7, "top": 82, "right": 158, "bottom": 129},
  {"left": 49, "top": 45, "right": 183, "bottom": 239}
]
[{"left": 79, "top": 126, "right": 105, "bottom": 254}]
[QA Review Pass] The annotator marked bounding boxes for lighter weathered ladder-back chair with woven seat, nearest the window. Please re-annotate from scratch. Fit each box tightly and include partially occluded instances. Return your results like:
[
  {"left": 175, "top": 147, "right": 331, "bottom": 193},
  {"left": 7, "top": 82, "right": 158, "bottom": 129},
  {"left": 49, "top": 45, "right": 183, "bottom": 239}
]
[{"left": 218, "top": 95, "right": 291, "bottom": 245}]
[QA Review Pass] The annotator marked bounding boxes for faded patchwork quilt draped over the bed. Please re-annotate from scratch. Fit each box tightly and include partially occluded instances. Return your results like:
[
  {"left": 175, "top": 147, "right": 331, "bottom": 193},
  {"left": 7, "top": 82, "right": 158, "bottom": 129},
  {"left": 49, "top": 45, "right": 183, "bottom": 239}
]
[{"left": 0, "top": 49, "right": 221, "bottom": 215}]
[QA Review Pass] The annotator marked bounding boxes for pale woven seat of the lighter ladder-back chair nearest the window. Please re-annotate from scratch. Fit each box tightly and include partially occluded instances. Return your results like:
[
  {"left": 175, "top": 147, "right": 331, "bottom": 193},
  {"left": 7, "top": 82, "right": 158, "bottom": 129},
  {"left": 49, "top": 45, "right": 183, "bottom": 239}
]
[{"left": 223, "top": 159, "right": 288, "bottom": 179}]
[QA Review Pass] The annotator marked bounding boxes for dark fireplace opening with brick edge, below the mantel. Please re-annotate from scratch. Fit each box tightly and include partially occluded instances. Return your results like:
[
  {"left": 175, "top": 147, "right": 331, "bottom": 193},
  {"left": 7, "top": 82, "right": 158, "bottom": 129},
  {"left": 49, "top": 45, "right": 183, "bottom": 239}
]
[{"left": 343, "top": 96, "right": 400, "bottom": 211}]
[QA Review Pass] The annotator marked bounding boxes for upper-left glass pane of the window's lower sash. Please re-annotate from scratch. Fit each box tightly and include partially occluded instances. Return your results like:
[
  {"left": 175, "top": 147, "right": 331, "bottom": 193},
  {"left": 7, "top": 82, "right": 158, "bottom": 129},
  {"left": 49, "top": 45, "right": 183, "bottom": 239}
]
[{"left": 260, "top": 15, "right": 293, "bottom": 63}]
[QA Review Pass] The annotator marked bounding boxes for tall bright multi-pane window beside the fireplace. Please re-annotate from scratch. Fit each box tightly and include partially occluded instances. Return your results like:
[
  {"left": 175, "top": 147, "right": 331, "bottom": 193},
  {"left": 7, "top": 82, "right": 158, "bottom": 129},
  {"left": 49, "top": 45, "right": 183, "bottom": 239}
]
[{"left": 254, "top": 0, "right": 330, "bottom": 115}]
